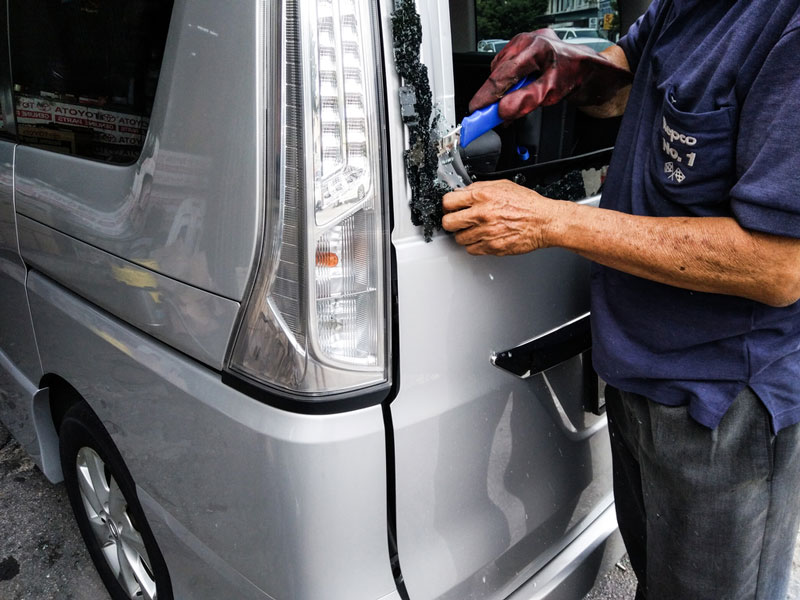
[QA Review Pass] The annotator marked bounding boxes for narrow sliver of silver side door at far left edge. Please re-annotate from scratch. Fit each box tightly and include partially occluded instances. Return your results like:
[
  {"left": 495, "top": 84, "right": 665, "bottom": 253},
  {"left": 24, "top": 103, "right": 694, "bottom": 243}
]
[{"left": 0, "top": 1, "right": 42, "bottom": 460}]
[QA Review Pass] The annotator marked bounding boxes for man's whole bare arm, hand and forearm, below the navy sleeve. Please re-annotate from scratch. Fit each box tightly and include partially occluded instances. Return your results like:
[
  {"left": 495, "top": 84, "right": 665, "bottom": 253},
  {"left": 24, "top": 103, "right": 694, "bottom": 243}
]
[{"left": 442, "top": 181, "right": 800, "bottom": 306}]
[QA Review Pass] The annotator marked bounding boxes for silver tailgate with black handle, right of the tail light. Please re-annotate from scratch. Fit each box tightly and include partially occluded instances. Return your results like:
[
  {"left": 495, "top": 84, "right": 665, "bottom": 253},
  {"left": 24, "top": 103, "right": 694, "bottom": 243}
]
[{"left": 384, "top": 0, "right": 636, "bottom": 600}]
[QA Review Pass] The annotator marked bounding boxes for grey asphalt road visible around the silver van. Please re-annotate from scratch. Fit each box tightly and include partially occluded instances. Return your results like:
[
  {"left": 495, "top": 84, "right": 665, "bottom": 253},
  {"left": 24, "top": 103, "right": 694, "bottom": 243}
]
[{"left": 0, "top": 424, "right": 800, "bottom": 600}]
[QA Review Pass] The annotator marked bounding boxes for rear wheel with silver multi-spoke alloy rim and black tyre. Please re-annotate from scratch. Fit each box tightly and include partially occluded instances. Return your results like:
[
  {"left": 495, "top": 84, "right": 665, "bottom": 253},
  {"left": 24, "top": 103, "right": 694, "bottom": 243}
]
[{"left": 59, "top": 402, "right": 172, "bottom": 600}]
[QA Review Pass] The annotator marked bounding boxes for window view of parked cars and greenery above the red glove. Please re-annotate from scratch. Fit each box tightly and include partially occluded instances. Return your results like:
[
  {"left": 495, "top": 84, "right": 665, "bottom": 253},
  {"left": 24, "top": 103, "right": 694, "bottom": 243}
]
[{"left": 475, "top": 0, "right": 619, "bottom": 52}]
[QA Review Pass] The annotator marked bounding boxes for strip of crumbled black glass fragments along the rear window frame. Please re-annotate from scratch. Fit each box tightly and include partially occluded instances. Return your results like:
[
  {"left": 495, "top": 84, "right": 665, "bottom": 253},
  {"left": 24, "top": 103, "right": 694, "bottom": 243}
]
[{"left": 392, "top": 0, "right": 450, "bottom": 242}]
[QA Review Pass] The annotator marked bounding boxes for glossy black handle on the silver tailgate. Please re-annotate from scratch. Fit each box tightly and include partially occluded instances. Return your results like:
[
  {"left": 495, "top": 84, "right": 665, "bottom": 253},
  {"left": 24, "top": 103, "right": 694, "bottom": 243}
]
[{"left": 491, "top": 312, "right": 592, "bottom": 379}]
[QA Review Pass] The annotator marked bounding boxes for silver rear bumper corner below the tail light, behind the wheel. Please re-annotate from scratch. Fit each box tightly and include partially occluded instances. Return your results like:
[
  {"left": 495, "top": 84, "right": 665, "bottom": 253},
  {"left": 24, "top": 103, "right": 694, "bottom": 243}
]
[{"left": 29, "top": 274, "right": 394, "bottom": 600}]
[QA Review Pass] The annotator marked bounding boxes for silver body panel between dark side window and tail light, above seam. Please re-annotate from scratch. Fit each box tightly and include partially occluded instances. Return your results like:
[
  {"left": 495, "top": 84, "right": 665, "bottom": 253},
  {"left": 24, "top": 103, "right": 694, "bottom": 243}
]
[{"left": 16, "top": 0, "right": 263, "bottom": 300}]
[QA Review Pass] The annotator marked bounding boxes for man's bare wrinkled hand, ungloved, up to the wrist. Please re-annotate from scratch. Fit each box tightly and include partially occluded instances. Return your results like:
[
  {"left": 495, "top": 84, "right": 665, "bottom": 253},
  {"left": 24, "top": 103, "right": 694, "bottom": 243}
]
[{"left": 442, "top": 180, "right": 561, "bottom": 256}]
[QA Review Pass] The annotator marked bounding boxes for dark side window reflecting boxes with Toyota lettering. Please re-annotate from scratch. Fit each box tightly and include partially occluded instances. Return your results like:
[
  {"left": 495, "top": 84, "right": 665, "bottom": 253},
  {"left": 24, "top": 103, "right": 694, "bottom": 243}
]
[{"left": 9, "top": 0, "right": 172, "bottom": 163}]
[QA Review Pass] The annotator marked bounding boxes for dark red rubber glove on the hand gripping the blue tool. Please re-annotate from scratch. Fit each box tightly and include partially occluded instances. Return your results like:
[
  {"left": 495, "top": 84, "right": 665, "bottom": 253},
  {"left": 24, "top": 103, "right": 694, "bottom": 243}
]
[{"left": 469, "top": 29, "right": 633, "bottom": 121}]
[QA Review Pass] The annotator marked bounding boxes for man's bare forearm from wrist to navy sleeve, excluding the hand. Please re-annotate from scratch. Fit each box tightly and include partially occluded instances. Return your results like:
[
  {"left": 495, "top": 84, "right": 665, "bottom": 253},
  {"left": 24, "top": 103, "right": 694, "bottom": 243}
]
[{"left": 543, "top": 202, "right": 800, "bottom": 306}]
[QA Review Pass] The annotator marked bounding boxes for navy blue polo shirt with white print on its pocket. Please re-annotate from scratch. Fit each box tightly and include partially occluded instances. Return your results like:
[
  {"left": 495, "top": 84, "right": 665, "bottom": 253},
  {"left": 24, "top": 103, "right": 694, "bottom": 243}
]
[{"left": 592, "top": 0, "right": 800, "bottom": 431}]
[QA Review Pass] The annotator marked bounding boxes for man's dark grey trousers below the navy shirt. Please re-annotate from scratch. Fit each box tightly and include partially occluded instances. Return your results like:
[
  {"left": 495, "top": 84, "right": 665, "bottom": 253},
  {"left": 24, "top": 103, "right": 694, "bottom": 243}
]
[{"left": 606, "top": 389, "right": 800, "bottom": 600}]
